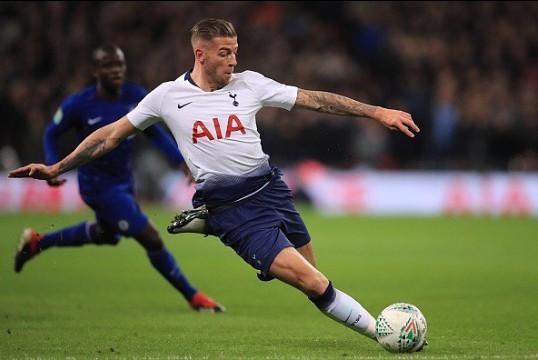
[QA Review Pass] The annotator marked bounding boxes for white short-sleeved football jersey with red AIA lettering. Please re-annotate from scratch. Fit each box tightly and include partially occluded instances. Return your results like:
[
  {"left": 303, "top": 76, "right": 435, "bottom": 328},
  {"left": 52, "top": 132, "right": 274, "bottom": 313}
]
[{"left": 127, "top": 71, "right": 297, "bottom": 182}]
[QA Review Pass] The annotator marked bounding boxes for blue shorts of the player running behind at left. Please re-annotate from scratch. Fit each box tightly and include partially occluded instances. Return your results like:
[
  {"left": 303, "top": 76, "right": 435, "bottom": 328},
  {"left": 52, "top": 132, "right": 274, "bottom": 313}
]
[{"left": 81, "top": 186, "right": 149, "bottom": 237}]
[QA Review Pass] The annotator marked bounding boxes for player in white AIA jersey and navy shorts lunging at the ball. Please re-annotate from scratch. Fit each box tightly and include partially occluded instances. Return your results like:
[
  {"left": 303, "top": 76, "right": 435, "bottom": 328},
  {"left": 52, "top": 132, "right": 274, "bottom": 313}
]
[{"left": 9, "top": 19, "right": 419, "bottom": 339}]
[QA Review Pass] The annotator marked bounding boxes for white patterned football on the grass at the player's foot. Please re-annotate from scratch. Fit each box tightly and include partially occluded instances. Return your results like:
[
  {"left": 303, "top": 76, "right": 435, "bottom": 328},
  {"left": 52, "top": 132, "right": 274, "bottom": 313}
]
[{"left": 375, "top": 303, "right": 428, "bottom": 353}]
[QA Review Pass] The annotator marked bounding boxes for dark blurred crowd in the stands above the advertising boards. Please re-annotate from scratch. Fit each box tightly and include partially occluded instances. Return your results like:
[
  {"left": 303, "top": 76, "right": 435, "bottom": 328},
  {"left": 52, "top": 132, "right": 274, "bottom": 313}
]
[{"left": 0, "top": 1, "right": 538, "bottom": 212}]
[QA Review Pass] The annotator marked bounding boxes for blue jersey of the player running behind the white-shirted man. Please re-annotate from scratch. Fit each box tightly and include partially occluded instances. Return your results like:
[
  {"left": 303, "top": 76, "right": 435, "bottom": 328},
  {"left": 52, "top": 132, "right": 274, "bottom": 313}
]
[{"left": 45, "top": 82, "right": 181, "bottom": 193}]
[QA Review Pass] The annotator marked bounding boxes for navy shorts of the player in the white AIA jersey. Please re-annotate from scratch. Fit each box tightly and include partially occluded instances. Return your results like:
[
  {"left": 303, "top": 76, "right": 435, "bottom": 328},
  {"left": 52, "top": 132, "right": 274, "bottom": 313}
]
[{"left": 208, "top": 172, "right": 310, "bottom": 274}]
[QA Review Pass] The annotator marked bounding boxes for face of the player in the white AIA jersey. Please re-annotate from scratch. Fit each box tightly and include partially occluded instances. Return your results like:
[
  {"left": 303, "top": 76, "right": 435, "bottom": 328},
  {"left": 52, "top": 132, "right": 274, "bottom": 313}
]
[{"left": 202, "top": 37, "right": 238, "bottom": 89}]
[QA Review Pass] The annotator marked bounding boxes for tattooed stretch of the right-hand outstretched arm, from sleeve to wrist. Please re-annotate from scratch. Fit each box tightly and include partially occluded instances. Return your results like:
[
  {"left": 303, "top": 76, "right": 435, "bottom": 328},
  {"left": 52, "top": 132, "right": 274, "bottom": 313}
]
[{"left": 297, "top": 89, "right": 376, "bottom": 118}]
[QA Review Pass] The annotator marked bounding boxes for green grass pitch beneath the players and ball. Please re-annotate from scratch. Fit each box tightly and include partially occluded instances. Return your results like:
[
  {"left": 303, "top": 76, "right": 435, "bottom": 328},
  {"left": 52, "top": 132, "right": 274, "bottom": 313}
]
[{"left": 0, "top": 209, "right": 538, "bottom": 360}]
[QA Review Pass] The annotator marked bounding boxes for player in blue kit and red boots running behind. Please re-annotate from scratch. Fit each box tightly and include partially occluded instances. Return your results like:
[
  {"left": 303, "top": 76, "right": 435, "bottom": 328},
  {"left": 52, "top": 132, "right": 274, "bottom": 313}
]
[{"left": 15, "top": 45, "right": 224, "bottom": 312}]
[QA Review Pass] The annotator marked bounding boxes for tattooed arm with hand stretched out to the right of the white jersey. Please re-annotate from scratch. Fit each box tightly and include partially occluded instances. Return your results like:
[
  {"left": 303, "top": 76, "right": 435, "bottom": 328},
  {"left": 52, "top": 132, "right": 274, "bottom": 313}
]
[{"left": 295, "top": 89, "right": 420, "bottom": 137}]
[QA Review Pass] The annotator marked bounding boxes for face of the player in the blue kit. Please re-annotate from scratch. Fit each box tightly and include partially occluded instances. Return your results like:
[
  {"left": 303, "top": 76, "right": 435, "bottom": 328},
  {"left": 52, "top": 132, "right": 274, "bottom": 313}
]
[{"left": 94, "top": 49, "right": 127, "bottom": 90}]
